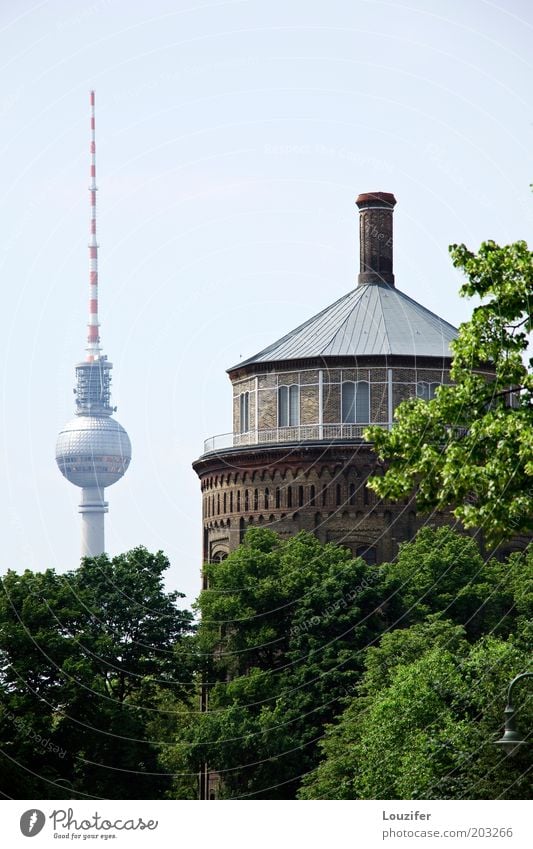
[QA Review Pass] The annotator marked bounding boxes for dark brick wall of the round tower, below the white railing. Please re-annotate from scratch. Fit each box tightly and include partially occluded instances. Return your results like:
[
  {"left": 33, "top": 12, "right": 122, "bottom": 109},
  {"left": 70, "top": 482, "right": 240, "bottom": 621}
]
[{"left": 199, "top": 444, "right": 436, "bottom": 563}]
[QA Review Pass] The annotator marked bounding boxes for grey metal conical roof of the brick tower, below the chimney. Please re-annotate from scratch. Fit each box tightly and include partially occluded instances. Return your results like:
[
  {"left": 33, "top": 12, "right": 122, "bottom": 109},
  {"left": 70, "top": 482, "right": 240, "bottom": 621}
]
[{"left": 230, "top": 283, "right": 457, "bottom": 371}]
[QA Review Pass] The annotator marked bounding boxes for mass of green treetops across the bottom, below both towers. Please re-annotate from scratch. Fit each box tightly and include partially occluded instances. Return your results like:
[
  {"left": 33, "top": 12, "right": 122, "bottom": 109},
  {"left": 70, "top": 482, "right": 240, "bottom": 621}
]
[{"left": 0, "top": 527, "right": 533, "bottom": 799}]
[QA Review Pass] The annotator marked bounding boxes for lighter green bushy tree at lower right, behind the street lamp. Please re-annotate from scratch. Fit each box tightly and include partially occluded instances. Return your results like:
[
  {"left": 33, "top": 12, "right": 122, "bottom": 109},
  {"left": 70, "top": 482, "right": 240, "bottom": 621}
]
[{"left": 300, "top": 621, "right": 533, "bottom": 799}]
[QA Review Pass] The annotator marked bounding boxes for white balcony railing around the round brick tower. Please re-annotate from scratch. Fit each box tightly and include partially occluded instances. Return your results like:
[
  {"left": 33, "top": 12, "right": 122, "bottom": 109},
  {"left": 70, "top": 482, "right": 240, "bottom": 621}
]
[{"left": 204, "top": 422, "right": 389, "bottom": 454}]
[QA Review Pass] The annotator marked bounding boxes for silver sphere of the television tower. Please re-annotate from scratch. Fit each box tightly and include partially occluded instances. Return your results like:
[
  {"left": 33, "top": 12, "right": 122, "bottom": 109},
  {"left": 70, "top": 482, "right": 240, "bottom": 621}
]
[{"left": 56, "top": 416, "right": 131, "bottom": 489}]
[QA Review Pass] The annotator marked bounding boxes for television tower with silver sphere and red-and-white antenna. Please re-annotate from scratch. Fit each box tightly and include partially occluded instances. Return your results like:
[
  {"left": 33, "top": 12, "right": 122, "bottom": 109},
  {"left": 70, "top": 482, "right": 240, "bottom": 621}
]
[{"left": 56, "top": 91, "right": 131, "bottom": 557}]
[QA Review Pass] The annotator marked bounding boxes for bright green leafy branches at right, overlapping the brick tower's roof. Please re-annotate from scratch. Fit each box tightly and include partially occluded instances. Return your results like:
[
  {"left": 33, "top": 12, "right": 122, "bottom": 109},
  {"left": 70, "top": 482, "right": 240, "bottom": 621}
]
[{"left": 365, "top": 241, "right": 533, "bottom": 544}]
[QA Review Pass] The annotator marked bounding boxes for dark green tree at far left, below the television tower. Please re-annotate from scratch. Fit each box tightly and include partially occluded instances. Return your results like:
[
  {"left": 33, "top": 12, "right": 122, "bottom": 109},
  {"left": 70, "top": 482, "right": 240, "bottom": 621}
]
[{"left": 0, "top": 547, "right": 193, "bottom": 798}]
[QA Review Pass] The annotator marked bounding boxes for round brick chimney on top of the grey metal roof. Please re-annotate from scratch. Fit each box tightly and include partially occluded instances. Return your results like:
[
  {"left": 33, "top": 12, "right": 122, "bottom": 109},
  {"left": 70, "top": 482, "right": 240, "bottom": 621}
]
[{"left": 356, "top": 192, "right": 396, "bottom": 286}]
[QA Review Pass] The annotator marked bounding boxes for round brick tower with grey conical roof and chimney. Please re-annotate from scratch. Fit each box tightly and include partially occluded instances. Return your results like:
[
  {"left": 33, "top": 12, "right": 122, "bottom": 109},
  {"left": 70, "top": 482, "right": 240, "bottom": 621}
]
[{"left": 193, "top": 192, "right": 456, "bottom": 563}]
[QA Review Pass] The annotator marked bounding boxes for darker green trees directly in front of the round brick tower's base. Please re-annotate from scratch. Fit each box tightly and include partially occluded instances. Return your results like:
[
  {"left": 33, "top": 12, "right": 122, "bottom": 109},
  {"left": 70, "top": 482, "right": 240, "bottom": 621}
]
[{"left": 170, "top": 527, "right": 533, "bottom": 799}]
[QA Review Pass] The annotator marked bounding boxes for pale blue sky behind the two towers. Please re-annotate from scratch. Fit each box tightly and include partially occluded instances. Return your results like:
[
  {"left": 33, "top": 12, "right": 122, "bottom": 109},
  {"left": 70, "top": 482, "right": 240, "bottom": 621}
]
[{"left": 0, "top": 0, "right": 533, "bottom": 596}]
